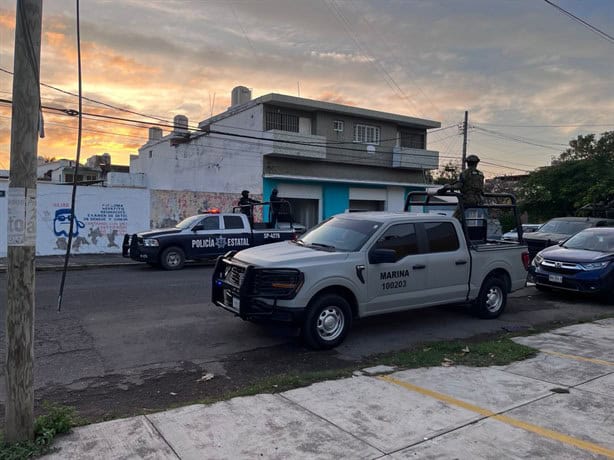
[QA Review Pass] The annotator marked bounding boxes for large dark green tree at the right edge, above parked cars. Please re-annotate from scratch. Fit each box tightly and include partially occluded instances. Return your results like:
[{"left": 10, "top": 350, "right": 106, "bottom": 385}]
[{"left": 519, "top": 131, "right": 614, "bottom": 219}]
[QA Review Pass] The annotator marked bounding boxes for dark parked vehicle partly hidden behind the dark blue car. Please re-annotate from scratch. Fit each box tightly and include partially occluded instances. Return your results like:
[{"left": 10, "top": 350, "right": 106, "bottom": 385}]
[{"left": 524, "top": 217, "right": 614, "bottom": 260}]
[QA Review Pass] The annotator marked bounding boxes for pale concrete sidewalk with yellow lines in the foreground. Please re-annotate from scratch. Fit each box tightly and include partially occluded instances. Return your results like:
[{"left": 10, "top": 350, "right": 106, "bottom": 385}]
[{"left": 45, "top": 319, "right": 614, "bottom": 459}]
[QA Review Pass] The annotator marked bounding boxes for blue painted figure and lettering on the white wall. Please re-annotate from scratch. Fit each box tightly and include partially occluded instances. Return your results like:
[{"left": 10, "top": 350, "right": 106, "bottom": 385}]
[{"left": 43, "top": 202, "right": 128, "bottom": 252}]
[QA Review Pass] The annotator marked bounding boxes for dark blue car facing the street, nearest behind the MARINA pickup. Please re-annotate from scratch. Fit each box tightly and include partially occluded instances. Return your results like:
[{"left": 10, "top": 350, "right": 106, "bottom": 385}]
[{"left": 529, "top": 228, "right": 614, "bottom": 301}]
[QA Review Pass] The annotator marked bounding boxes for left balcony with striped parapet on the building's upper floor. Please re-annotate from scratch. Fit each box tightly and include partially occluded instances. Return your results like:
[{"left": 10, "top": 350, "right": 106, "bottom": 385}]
[{"left": 262, "top": 129, "right": 326, "bottom": 159}]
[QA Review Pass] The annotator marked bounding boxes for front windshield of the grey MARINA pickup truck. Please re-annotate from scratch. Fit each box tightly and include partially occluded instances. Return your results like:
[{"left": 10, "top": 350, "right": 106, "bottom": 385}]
[{"left": 297, "top": 217, "right": 381, "bottom": 252}]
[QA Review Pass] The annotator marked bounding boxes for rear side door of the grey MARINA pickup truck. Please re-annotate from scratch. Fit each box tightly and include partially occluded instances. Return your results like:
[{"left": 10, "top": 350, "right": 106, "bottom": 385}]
[{"left": 423, "top": 222, "right": 470, "bottom": 303}]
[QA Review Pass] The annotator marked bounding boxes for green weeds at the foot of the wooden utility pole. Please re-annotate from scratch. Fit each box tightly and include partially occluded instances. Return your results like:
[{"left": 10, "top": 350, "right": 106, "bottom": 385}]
[{"left": 0, "top": 404, "right": 76, "bottom": 460}]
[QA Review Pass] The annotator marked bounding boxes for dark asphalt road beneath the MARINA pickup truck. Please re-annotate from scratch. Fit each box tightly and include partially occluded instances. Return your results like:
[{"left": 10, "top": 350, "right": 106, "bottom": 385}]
[{"left": 0, "top": 265, "right": 614, "bottom": 420}]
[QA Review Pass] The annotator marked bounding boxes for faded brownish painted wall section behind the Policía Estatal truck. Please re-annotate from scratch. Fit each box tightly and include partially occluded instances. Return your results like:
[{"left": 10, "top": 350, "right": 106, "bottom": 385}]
[{"left": 151, "top": 190, "right": 261, "bottom": 228}]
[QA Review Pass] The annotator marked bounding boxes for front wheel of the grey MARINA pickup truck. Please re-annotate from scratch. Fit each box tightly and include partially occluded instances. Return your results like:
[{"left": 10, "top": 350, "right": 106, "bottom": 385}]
[{"left": 301, "top": 294, "right": 352, "bottom": 350}]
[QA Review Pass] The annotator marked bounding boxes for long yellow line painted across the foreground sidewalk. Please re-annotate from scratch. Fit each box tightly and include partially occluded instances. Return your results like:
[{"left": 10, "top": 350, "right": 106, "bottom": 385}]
[{"left": 377, "top": 375, "right": 614, "bottom": 458}]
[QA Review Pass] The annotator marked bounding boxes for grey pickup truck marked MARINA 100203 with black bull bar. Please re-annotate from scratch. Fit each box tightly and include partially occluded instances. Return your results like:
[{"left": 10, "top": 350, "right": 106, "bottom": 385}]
[{"left": 212, "top": 191, "right": 528, "bottom": 348}]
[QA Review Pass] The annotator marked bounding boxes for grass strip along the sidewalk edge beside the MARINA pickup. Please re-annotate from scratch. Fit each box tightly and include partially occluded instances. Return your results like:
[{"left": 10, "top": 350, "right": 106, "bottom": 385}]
[{"left": 377, "top": 338, "right": 537, "bottom": 369}]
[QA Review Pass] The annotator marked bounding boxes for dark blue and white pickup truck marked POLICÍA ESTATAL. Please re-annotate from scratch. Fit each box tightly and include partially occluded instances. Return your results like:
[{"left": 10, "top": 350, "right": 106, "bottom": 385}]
[{"left": 122, "top": 212, "right": 296, "bottom": 270}]
